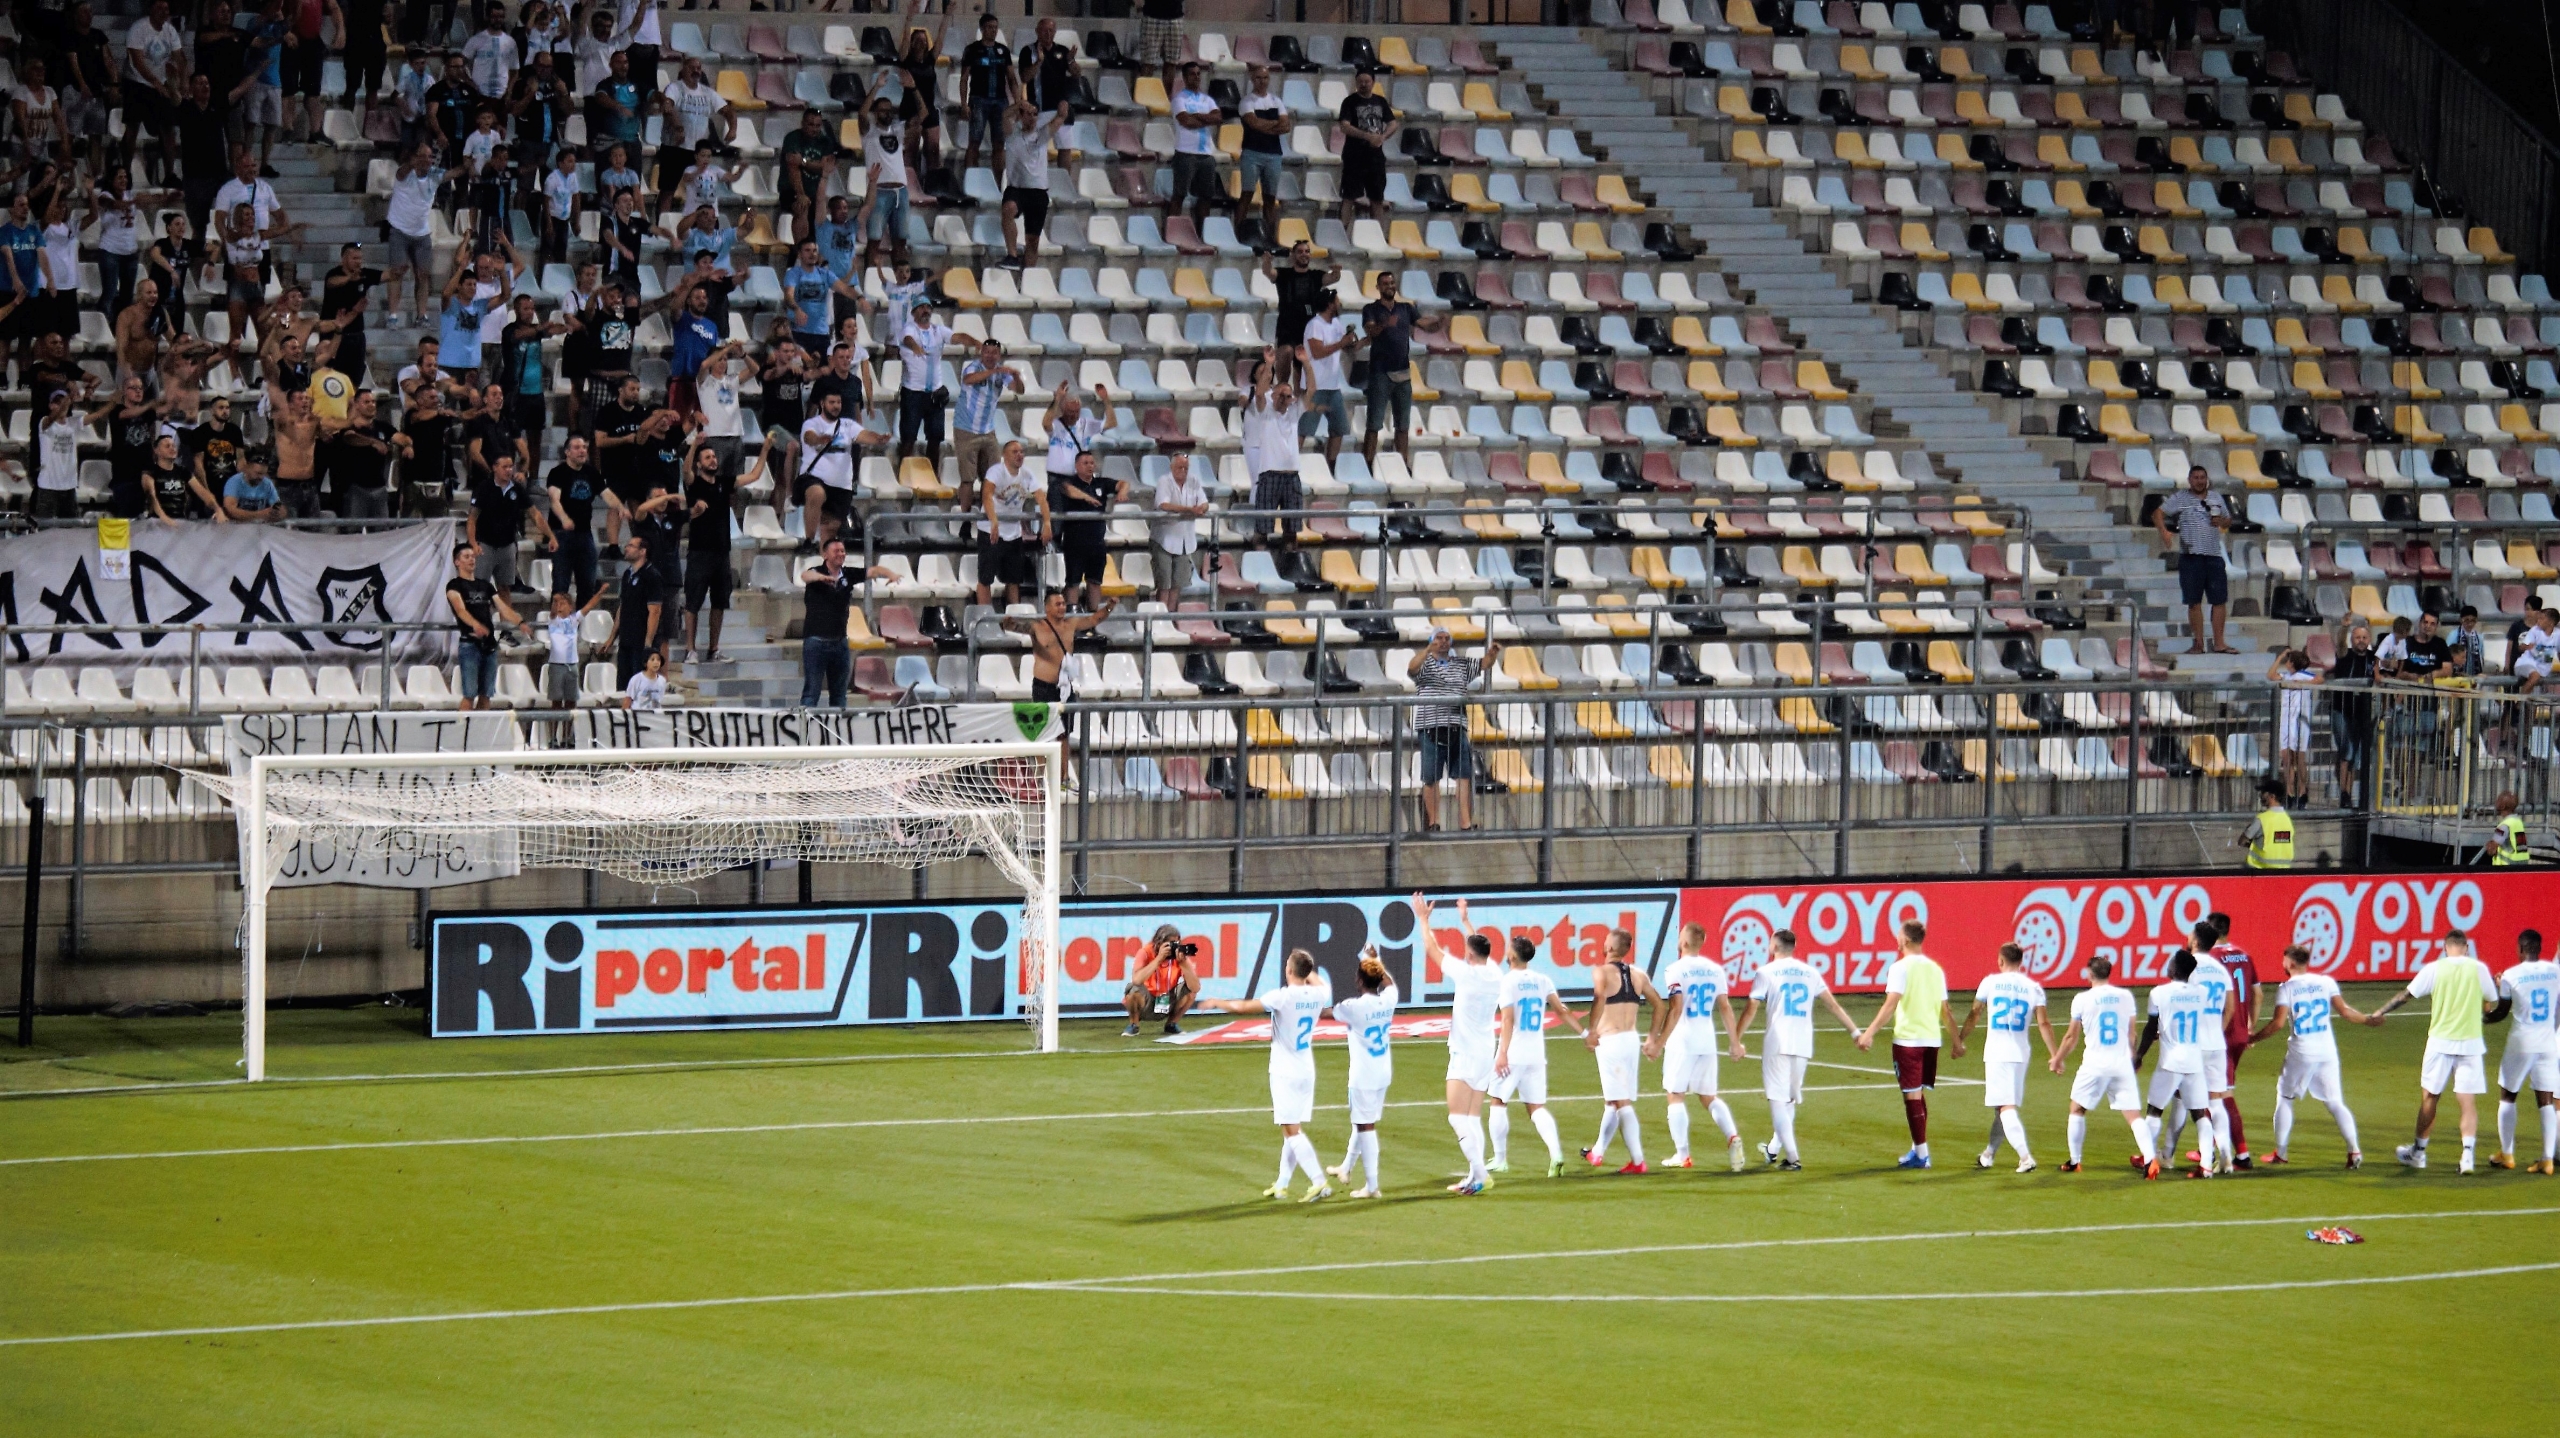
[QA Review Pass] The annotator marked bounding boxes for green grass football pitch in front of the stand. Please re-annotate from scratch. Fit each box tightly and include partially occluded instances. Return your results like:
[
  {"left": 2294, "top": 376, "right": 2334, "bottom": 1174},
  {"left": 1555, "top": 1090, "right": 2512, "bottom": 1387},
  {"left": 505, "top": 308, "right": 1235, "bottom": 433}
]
[{"left": 0, "top": 993, "right": 2560, "bottom": 1438}]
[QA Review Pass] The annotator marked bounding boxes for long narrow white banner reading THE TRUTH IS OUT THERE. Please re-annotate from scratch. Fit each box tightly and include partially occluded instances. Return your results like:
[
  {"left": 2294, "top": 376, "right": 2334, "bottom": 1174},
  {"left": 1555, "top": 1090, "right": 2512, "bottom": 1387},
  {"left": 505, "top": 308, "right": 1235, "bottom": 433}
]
[{"left": 571, "top": 704, "right": 1057, "bottom": 750}]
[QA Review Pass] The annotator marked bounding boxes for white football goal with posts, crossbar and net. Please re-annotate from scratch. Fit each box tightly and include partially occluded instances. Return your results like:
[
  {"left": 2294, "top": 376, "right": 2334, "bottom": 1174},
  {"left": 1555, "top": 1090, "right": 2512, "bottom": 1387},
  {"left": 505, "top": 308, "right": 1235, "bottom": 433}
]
[{"left": 220, "top": 742, "right": 1062, "bottom": 1082}]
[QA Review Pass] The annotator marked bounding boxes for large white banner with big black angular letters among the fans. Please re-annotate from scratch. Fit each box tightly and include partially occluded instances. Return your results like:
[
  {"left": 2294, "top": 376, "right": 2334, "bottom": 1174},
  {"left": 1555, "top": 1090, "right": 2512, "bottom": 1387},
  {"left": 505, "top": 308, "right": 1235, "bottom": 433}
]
[{"left": 0, "top": 519, "right": 458, "bottom": 678}]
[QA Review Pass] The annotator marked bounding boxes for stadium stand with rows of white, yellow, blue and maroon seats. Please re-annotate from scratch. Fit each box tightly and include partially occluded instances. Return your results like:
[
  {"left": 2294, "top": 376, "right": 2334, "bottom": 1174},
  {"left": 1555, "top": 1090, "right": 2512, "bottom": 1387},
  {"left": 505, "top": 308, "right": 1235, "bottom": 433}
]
[{"left": 0, "top": 0, "right": 2560, "bottom": 849}]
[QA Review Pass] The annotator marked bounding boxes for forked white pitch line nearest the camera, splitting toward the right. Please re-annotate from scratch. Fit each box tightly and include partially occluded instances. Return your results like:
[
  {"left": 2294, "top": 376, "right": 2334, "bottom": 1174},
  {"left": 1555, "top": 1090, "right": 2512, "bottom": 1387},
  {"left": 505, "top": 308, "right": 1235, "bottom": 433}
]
[{"left": 0, "top": 1208, "right": 2560, "bottom": 1348}]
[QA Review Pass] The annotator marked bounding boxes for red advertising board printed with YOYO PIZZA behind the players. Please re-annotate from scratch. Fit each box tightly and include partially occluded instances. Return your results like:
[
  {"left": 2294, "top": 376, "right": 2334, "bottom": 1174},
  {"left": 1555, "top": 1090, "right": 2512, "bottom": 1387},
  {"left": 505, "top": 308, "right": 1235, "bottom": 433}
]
[{"left": 1679, "top": 870, "right": 2560, "bottom": 993}]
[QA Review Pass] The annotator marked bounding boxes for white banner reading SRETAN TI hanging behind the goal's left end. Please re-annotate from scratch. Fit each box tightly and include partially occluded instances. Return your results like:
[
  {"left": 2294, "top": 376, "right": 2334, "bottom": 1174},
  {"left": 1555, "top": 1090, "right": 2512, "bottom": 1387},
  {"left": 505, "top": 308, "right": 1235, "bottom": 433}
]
[{"left": 223, "top": 714, "right": 522, "bottom": 888}]
